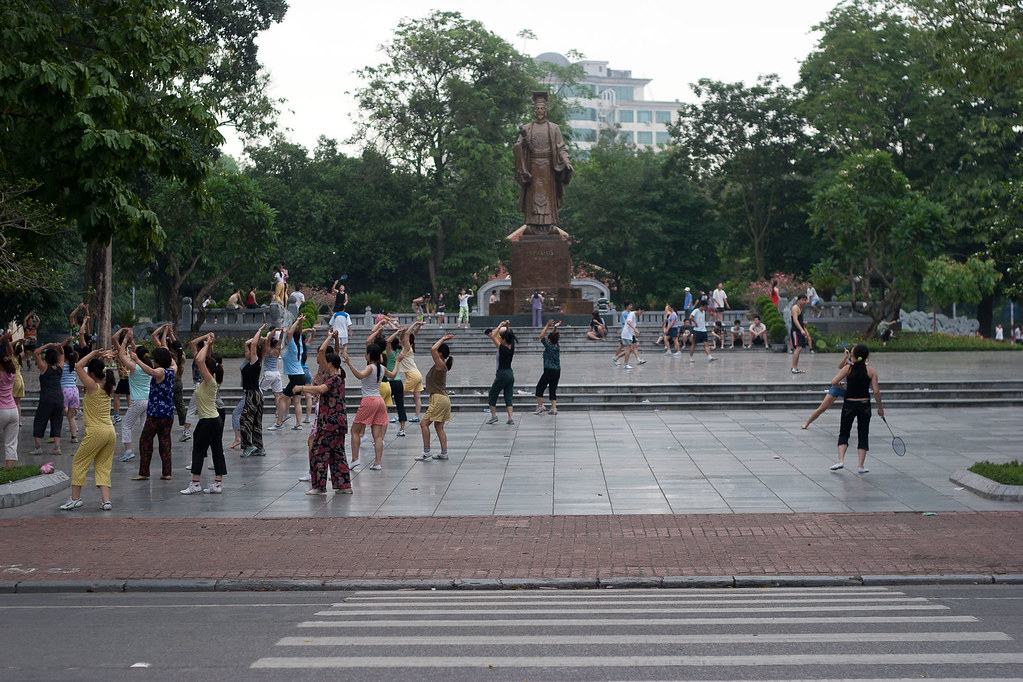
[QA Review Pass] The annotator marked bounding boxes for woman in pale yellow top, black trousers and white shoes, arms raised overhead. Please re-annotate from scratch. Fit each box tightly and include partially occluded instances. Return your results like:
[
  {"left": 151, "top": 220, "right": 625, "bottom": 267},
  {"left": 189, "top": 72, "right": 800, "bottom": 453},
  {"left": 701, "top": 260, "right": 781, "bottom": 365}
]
[{"left": 181, "top": 332, "right": 227, "bottom": 495}]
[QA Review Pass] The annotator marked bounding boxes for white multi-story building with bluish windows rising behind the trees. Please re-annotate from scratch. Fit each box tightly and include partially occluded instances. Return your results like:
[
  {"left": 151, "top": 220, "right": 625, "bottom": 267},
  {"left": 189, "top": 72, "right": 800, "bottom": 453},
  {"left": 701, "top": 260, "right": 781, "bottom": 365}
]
[{"left": 536, "top": 52, "right": 679, "bottom": 150}]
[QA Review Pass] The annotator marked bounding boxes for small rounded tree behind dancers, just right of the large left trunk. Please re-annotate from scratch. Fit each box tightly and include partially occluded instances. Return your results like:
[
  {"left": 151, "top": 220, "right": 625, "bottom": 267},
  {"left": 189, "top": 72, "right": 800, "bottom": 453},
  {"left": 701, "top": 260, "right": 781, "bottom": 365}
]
[{"left": 148, "top": 171, "right": 277, "bottom": 331}]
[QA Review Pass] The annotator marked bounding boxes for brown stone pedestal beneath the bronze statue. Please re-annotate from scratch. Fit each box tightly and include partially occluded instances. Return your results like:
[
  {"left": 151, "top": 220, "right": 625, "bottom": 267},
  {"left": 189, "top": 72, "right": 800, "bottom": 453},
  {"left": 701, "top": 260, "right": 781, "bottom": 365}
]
[{"left": 490, "top": 231, "right": 593, "bottom": 315}]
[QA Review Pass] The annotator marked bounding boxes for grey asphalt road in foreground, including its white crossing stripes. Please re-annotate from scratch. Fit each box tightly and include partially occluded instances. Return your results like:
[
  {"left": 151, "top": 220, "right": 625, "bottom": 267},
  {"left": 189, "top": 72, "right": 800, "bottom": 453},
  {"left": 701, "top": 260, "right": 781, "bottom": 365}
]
[{"left": 6, "top": 586, "right": 1023, "bottom": 681}]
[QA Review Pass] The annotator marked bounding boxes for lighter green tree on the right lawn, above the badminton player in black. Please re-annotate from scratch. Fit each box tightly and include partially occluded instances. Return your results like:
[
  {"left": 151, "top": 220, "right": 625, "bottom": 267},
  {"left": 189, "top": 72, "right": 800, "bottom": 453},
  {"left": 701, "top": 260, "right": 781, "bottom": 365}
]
[{"left": 809, "top": 151, "right": 946, "bottom": 332}]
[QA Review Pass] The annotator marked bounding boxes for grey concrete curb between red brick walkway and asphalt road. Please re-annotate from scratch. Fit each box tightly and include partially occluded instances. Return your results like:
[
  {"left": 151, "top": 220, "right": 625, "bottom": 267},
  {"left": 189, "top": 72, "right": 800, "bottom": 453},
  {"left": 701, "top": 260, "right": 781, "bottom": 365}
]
[{"left": 0, "top": 574, "right": 1023, "bottom": 594}]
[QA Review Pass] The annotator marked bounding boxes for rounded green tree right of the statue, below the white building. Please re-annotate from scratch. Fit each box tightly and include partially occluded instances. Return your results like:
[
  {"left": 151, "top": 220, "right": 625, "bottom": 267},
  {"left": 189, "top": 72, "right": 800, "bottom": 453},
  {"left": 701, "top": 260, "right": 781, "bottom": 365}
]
[{"left": 564, "top": 136, "right": 719, "bottom": 300}]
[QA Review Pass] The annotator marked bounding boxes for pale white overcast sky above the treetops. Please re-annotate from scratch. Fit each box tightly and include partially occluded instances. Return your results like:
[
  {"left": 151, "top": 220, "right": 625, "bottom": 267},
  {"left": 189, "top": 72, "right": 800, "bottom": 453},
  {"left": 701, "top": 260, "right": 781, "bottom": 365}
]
[{"left": 225, "top": 0, "right": 836, "bottom": 156}]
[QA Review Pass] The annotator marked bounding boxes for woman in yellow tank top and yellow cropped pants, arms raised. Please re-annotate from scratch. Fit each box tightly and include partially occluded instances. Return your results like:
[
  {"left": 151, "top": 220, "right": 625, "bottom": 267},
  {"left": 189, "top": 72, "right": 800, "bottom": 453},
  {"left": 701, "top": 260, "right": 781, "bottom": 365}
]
[{"left": 60, "top": 351, "right": 117, "bottom": 511}]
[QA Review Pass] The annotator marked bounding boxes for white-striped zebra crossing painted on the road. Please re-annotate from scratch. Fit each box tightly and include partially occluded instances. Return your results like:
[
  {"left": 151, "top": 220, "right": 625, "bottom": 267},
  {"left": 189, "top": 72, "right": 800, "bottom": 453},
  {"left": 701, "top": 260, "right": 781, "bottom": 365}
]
[{"left": 252, "top": 587, "right": 1023, "bottom": 682}]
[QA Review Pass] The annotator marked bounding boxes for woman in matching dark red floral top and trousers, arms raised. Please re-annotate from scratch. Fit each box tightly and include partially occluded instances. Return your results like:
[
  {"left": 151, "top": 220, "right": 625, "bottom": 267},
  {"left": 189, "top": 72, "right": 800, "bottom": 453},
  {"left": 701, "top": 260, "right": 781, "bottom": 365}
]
[{"left": 297, "top": 330, "right": 352, "bottom": 495}]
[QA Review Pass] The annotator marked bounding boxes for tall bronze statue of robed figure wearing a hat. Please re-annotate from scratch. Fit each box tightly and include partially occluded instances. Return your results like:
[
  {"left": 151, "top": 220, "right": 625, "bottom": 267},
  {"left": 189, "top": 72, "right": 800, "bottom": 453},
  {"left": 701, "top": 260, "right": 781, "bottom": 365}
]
[{"left": 514, "top": 91, "right": 573, "bottom": 234}]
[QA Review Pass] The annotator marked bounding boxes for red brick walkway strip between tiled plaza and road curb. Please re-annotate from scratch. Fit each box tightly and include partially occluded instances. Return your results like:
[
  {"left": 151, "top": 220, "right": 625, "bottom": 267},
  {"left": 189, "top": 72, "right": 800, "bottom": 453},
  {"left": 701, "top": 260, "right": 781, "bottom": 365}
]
[{"left": 0, "top": 511, "right": 1023, "bottom": 581}]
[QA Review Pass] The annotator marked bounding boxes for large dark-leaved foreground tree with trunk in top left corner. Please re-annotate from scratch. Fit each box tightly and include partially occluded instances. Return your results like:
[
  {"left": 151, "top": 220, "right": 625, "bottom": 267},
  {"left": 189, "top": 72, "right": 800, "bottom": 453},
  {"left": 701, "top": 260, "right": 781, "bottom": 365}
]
[{"left": 0, "top": 0, "right": 228, "bottom": 337}]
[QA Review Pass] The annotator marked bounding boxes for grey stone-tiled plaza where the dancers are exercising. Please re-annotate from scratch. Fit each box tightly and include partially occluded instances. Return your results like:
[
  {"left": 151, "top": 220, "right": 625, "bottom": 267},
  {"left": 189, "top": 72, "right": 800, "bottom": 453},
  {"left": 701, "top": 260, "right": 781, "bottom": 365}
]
[{"left": 7, "top": 351, "right": 1023, "bottom": 518}]
